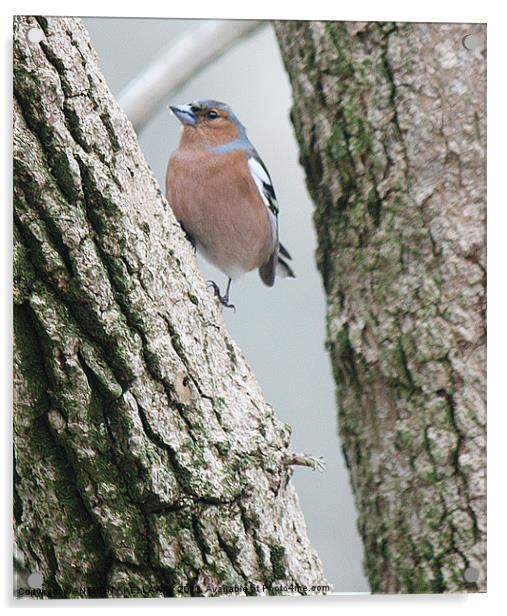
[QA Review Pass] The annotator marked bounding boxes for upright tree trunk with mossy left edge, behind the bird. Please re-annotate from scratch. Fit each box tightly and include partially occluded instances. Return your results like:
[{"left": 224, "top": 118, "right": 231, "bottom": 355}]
[{"left": 276, "top": 22, "right": 486, "bottom": 592}]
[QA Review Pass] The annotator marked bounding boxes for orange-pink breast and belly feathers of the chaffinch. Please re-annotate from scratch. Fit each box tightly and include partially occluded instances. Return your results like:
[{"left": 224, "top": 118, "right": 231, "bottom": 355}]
[{"left": 166, "top": 148, "right": 276, "bottom": 279}]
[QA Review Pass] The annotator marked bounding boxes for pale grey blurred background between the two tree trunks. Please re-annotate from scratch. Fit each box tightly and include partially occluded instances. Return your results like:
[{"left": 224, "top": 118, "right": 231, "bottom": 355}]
[{"left": 83, "top": 18, "right": 368, "bottom": 592}]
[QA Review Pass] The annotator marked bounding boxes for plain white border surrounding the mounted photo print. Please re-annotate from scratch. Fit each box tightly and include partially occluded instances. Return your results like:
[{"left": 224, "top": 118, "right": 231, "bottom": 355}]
[{"left": 0, "top": 0, "right": 506, "bottom": 613}]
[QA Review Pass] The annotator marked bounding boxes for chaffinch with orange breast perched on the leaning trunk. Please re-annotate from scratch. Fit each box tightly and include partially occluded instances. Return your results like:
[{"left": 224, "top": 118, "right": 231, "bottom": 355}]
[{"left": 166, "top": 100, "right": 294, "bottom": 308}]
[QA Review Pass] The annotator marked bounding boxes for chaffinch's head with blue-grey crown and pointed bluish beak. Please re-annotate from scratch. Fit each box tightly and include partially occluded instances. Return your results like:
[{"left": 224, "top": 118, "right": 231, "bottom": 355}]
[{"left": 170, "top": 100, "right": 245, "bottom": 143}]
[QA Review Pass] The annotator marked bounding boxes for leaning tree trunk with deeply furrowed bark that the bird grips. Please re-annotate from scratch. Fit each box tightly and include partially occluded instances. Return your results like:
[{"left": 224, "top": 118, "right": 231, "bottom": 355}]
[{"left": 14, "top": 17, "right": 325, "bottom": 597}]
